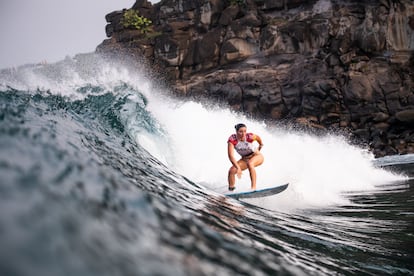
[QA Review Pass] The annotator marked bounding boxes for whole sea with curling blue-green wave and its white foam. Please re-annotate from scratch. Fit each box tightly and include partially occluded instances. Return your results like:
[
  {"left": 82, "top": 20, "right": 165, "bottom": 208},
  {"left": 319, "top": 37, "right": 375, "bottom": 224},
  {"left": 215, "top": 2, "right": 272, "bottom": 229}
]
[{"left": 0, "top": 54, "right": 414, "bottom": 275}]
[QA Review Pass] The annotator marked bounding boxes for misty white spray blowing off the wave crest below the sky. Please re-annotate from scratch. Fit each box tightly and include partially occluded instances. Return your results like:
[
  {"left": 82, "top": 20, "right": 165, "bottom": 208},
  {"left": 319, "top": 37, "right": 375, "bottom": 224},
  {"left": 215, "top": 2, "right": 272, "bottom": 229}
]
[{"left": 0, "top": 53, "right": 149, "bottom": 100}]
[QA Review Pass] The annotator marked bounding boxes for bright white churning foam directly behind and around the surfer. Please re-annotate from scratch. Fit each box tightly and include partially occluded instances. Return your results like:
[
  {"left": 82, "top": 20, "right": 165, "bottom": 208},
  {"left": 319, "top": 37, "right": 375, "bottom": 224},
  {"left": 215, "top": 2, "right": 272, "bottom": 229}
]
[{"left": 141, "top": 94, "right": 405, "bottom": 209}]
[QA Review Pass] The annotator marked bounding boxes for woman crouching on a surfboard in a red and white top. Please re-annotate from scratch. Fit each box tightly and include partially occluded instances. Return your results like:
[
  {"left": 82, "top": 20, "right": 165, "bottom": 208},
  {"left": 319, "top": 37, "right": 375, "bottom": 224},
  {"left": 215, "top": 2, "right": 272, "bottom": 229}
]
[{"left": 227, "top": 124, "right": 264, "bottom": 191}]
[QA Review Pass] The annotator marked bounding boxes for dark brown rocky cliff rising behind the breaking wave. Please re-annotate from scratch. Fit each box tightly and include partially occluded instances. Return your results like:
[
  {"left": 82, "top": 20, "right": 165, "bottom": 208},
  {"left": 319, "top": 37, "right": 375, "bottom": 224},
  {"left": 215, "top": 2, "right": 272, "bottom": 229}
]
[{"left": 97, "top": 0, "right": 414, "bottom": 156}]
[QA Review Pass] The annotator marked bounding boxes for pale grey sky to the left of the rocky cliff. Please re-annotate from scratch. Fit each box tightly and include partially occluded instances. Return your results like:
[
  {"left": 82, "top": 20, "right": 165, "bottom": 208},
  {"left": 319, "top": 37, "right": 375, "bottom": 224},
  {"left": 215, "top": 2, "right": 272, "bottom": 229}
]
[{"left": 0, "top": 0, "right": 135, "bottom": 68}]
